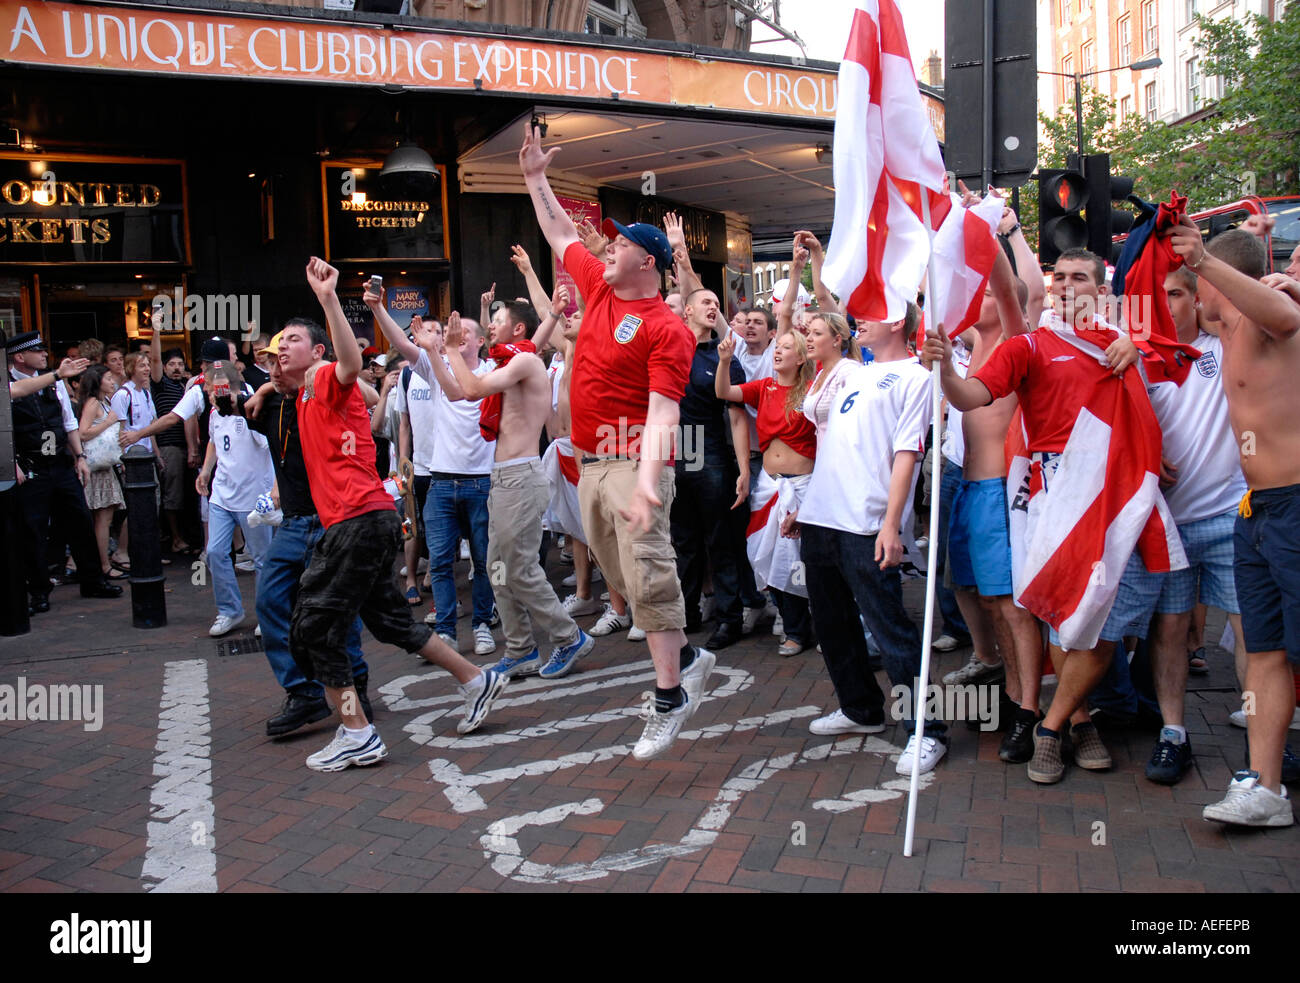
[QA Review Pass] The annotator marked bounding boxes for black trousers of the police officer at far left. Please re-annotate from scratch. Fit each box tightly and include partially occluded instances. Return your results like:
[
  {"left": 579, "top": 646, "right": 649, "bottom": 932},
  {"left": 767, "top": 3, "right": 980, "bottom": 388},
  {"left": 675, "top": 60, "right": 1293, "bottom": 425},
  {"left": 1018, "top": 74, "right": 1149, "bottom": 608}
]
[{"left": 17, "top": 464, "right": 103, "bottom": 597}]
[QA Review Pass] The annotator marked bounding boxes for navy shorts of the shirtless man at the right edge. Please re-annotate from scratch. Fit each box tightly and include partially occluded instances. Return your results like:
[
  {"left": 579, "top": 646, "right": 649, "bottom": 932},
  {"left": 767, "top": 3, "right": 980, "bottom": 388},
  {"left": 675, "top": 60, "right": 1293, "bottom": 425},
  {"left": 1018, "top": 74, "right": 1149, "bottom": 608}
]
[{"left": 1232, "top": 485, "right": 1300, "bottom": 664}]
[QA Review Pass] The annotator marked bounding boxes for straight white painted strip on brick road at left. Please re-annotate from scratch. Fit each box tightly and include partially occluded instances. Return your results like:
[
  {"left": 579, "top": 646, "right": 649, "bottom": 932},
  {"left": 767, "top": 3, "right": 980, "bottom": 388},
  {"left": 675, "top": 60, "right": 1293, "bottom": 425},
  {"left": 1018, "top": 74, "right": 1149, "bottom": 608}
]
[{"left": 140, "top": 659, "right": 217, "bottom": 893}]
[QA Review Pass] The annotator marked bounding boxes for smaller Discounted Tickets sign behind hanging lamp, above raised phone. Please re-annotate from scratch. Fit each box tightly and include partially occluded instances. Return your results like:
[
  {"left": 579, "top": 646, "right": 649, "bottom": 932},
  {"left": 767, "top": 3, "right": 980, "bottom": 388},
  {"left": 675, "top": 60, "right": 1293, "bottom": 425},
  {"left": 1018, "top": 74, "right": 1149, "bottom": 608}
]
[{"left": 321, "top": 163, "right": 447, "bottom": 261}]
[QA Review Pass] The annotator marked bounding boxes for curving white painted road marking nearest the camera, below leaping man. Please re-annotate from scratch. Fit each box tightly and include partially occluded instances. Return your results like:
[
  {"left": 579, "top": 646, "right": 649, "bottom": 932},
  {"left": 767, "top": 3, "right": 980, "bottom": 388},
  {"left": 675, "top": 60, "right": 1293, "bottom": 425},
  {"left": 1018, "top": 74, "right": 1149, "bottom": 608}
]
[{"left": 478, "top": 728, "right": 933, "bottom": 884}]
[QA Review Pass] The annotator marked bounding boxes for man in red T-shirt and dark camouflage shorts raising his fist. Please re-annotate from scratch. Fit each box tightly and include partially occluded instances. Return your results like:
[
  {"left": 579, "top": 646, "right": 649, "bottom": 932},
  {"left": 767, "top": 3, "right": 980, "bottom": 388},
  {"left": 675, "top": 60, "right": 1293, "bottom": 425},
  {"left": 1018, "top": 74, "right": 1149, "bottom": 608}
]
[{"left": 280, "top": 256, "right": 507, "bottom": 771}]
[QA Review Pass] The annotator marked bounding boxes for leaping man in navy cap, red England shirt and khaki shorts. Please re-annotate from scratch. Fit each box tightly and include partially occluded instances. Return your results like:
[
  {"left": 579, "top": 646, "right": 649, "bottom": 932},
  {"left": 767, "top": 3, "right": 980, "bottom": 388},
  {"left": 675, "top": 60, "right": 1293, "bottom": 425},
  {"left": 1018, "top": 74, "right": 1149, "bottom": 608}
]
[{"left": 519, "top": 120, "right": 716, "bottom": 761}]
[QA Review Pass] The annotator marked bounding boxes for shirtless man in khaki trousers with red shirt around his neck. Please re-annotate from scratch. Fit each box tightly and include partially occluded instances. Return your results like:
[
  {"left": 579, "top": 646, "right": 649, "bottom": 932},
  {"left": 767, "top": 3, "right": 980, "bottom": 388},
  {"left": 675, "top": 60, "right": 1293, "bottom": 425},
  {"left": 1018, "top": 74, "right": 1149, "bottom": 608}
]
[{"left": 445, "top": 301, "right": 595, "bottom": 679}]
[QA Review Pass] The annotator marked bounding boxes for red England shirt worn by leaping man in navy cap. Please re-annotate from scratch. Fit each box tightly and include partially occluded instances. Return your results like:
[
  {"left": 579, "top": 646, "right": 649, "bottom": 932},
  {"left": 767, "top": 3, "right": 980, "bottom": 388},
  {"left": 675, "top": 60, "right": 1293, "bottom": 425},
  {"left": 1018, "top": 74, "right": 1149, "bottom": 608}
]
[{"left": 564, "top": 242, "right": 696, "bottom": 458}]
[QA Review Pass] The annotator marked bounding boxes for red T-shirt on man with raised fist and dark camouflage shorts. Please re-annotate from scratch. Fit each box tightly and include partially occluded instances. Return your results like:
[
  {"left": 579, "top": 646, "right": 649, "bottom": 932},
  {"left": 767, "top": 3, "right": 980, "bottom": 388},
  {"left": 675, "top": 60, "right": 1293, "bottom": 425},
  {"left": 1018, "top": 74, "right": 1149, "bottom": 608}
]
[{"left": 298, "top": 361, "right": 395, "bottom": 529}]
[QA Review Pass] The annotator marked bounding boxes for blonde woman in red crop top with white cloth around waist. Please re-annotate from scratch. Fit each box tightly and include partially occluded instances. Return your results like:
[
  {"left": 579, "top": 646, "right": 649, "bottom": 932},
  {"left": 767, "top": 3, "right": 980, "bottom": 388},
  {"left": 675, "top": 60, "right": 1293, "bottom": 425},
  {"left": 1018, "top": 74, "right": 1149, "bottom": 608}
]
[{"left": 714, "top": 330, "right": 816, "bottom": 655}]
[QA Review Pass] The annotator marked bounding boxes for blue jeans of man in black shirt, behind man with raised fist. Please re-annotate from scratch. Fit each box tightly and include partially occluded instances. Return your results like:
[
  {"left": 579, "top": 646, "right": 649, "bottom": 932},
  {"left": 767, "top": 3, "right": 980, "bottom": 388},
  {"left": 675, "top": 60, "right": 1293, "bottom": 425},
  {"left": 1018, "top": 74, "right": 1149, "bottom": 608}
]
[{"left": 257, "top": 515, "right": 371, "bottom": 698}]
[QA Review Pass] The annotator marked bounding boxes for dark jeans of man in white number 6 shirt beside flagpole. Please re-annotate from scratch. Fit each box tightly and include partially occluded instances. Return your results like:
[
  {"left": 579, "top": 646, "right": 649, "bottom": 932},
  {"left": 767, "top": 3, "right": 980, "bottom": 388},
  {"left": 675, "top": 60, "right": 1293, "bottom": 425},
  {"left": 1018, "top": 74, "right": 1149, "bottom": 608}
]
[{"left": 800, "top": 525, "right": 948, "bottom": 739}]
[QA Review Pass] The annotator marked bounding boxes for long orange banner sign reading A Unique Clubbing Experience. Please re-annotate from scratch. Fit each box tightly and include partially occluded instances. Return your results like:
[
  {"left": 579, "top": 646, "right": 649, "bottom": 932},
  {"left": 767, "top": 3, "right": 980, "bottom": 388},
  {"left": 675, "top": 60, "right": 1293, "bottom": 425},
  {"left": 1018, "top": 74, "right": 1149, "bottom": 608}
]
[{"left": 0, "top": 1, "right": 915, "bottom": 124}]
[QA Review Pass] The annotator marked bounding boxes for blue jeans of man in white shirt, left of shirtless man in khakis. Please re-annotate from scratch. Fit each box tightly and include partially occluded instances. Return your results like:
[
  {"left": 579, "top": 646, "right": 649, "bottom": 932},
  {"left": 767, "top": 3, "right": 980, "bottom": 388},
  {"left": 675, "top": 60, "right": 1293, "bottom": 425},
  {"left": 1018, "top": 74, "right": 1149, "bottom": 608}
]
[{"left": 424, "top": 475, "right": 495, "bottom": 638}]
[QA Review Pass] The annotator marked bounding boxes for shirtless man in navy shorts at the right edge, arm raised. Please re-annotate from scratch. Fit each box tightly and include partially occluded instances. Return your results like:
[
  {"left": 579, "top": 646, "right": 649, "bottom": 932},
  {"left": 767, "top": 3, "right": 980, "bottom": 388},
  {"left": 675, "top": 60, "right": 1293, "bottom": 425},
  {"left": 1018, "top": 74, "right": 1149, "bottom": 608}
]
[{"left": 1169, "top": 218, "right": 1300, "bottom": 826}]
